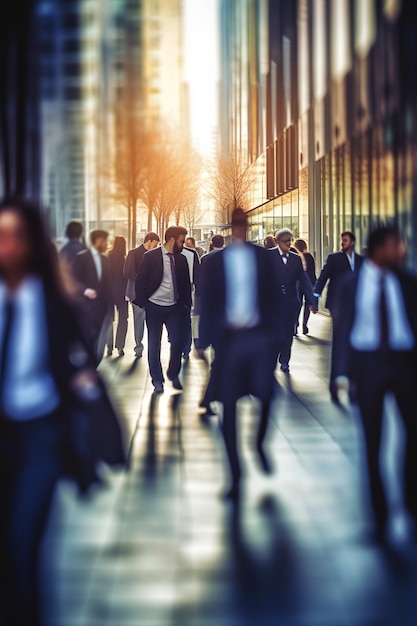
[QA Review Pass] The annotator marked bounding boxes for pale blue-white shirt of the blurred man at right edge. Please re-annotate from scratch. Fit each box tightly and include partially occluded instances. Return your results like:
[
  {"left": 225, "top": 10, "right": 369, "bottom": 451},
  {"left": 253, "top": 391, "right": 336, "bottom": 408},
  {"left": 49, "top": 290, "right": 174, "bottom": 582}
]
[{"left": 350, "top": 259, "right": 415, "bottom": 351}]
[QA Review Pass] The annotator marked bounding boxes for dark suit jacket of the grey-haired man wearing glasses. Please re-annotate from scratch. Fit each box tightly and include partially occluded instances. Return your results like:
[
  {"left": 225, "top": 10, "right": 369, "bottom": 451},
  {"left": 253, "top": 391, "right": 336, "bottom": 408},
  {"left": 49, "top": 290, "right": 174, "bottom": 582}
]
[{"left": 267, "top": 248, "right": 316, "bottom": 314}]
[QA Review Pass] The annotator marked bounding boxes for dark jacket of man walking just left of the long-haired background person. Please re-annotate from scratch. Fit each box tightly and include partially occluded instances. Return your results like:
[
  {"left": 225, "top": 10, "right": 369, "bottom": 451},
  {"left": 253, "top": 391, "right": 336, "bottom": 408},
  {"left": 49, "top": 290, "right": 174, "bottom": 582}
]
[{"left": 74, "top": 250, "right": 113, "bottom": 321}]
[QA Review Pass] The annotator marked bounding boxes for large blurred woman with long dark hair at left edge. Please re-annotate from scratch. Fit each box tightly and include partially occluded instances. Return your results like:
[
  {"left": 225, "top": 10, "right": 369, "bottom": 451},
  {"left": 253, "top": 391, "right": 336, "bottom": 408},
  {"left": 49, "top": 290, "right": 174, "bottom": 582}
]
[{"left": 0, "top": 198, "right": 124, "bottom": 626}]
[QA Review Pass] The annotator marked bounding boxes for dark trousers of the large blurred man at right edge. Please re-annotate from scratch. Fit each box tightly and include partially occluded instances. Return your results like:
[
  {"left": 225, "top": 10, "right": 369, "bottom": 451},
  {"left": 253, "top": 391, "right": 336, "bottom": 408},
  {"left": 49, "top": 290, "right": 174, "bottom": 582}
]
[{"left": 352, "top": 352, "right": 417, "bottom": 527}]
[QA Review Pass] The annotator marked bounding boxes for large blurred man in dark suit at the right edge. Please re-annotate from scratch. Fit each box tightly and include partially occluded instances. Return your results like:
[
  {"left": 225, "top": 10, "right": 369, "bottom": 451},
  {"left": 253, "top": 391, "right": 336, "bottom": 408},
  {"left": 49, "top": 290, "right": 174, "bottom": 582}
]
[{"left": 334, "top": 227, "right": 417, "bottom": 540}]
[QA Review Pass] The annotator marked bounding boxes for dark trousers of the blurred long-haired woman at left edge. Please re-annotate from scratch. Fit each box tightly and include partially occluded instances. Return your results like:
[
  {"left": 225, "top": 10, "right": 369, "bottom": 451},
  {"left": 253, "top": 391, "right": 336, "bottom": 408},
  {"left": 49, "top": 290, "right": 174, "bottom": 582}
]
[{"left": 0, "top": 414, "right": 62, "bottom": 626}]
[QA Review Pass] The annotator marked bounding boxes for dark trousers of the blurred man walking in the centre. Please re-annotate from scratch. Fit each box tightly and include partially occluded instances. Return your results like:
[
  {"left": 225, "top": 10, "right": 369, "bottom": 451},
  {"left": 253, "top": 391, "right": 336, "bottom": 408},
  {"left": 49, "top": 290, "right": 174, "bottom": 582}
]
[{"left": 213, "top": 328, "right": 277, "bottom": 483}]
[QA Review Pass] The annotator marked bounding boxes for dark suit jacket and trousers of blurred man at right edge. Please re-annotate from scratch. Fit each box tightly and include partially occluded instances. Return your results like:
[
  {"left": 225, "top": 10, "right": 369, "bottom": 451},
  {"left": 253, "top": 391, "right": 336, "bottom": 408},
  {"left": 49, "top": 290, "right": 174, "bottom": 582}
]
[{"left": 333, "top": 272, "right": 417, "bottom": 532}]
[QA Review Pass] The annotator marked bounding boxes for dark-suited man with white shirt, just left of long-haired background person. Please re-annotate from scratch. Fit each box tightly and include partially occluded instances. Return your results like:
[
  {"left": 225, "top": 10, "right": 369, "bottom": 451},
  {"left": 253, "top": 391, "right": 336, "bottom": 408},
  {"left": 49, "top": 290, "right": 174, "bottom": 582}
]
[{"left": 73, "top": 229, "right": 112, "bottom": 365}]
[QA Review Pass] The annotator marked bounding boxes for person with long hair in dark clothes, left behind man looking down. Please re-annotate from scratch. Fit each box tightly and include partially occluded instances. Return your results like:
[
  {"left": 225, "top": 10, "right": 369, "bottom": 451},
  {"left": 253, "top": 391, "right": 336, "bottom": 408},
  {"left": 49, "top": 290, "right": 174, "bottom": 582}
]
[{"left": 107, "top": 235, "right": 129, "bottom": 356}]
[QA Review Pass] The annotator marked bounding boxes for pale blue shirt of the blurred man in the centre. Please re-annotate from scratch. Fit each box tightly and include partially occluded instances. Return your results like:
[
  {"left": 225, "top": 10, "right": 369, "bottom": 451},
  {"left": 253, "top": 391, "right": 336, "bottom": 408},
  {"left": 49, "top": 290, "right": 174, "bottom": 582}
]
[{"left": 224, "top": 243, "right": 260, "bottom": 329}]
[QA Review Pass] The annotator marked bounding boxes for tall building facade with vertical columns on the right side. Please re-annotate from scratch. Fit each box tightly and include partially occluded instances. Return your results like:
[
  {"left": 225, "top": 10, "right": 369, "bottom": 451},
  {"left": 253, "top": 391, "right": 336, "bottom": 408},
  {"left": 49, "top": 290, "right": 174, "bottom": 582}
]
[{"left": 220, "top": 0, "right": 417, "bottom": 267}]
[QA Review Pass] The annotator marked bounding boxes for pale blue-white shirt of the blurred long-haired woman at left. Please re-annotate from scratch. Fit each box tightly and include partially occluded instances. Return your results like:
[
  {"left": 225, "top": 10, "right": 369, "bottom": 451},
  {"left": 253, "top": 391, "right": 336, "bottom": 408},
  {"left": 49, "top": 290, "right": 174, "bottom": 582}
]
[{"left": 0, "top": 277, "right": 60, "bottom": 420}]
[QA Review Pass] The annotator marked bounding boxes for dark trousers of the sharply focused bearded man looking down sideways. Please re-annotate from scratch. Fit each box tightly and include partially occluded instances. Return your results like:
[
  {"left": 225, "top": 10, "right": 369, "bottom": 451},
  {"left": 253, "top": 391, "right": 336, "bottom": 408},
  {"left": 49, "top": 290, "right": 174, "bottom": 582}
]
[{"left": 146, "top": 301, "right": 190, "bottom": 385}]
